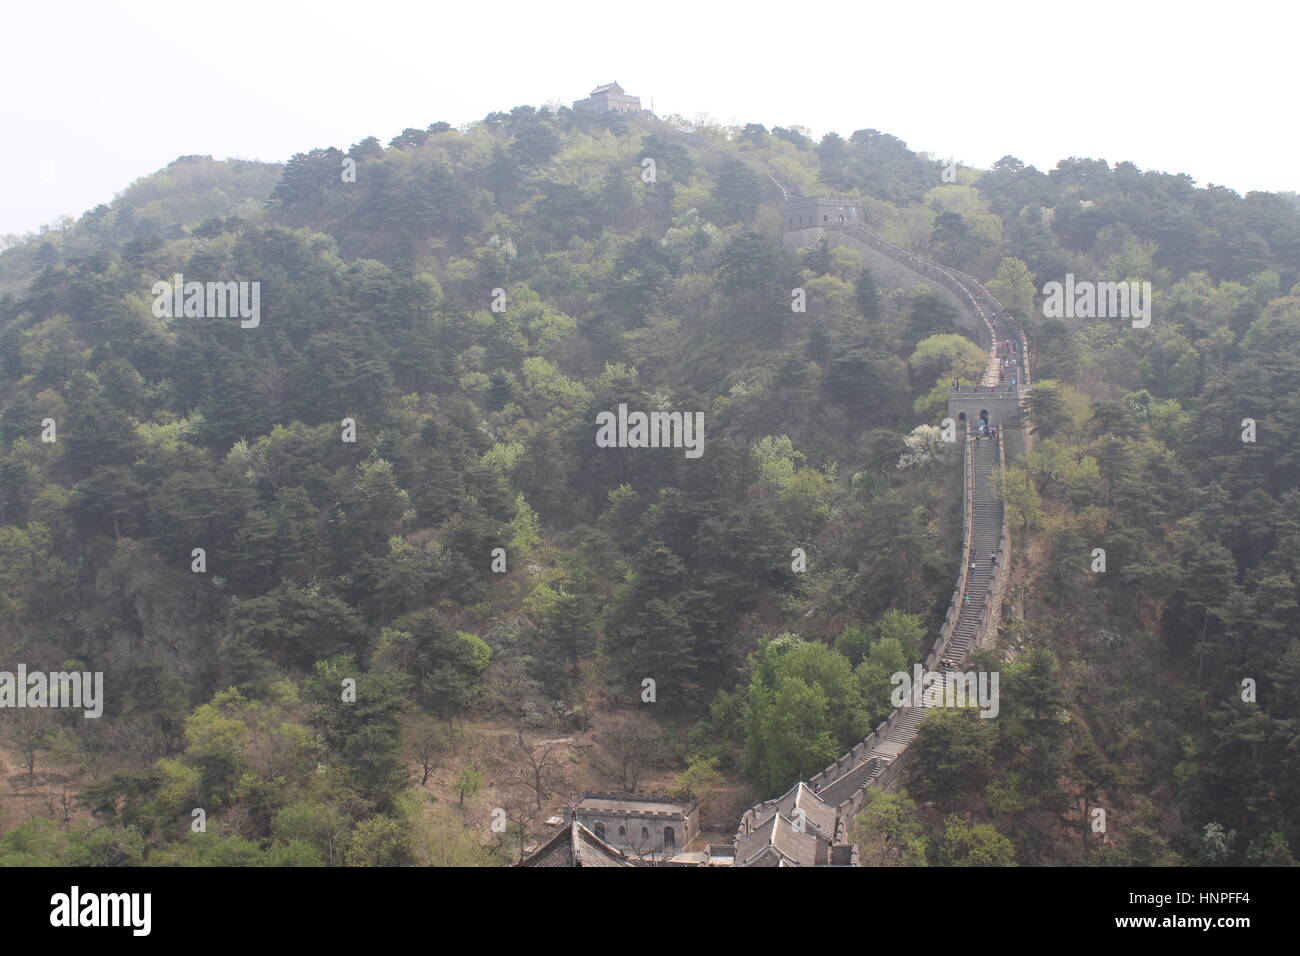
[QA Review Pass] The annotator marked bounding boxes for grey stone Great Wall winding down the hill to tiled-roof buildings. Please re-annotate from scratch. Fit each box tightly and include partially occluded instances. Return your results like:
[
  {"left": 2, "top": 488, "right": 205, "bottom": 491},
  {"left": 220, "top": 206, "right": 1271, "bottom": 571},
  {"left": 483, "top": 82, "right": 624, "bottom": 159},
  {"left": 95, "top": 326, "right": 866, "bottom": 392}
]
[{"left": 523, "top": 127, "right": 1034, "bottom": 866}]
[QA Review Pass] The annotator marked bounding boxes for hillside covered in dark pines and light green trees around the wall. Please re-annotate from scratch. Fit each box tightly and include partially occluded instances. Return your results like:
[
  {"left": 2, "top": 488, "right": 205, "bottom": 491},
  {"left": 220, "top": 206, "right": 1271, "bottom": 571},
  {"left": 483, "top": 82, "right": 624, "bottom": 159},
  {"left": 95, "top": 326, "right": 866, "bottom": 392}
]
[{"left": 0, "top": 107, "right": 1300, "bottom": 866}]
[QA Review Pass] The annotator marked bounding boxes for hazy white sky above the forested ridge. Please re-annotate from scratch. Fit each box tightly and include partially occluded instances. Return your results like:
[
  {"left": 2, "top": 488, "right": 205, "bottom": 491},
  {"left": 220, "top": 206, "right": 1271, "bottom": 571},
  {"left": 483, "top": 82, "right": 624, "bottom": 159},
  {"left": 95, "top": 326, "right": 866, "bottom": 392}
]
[{"left": 0, "top": 0, "right": 1300, "bottom": 234}]
